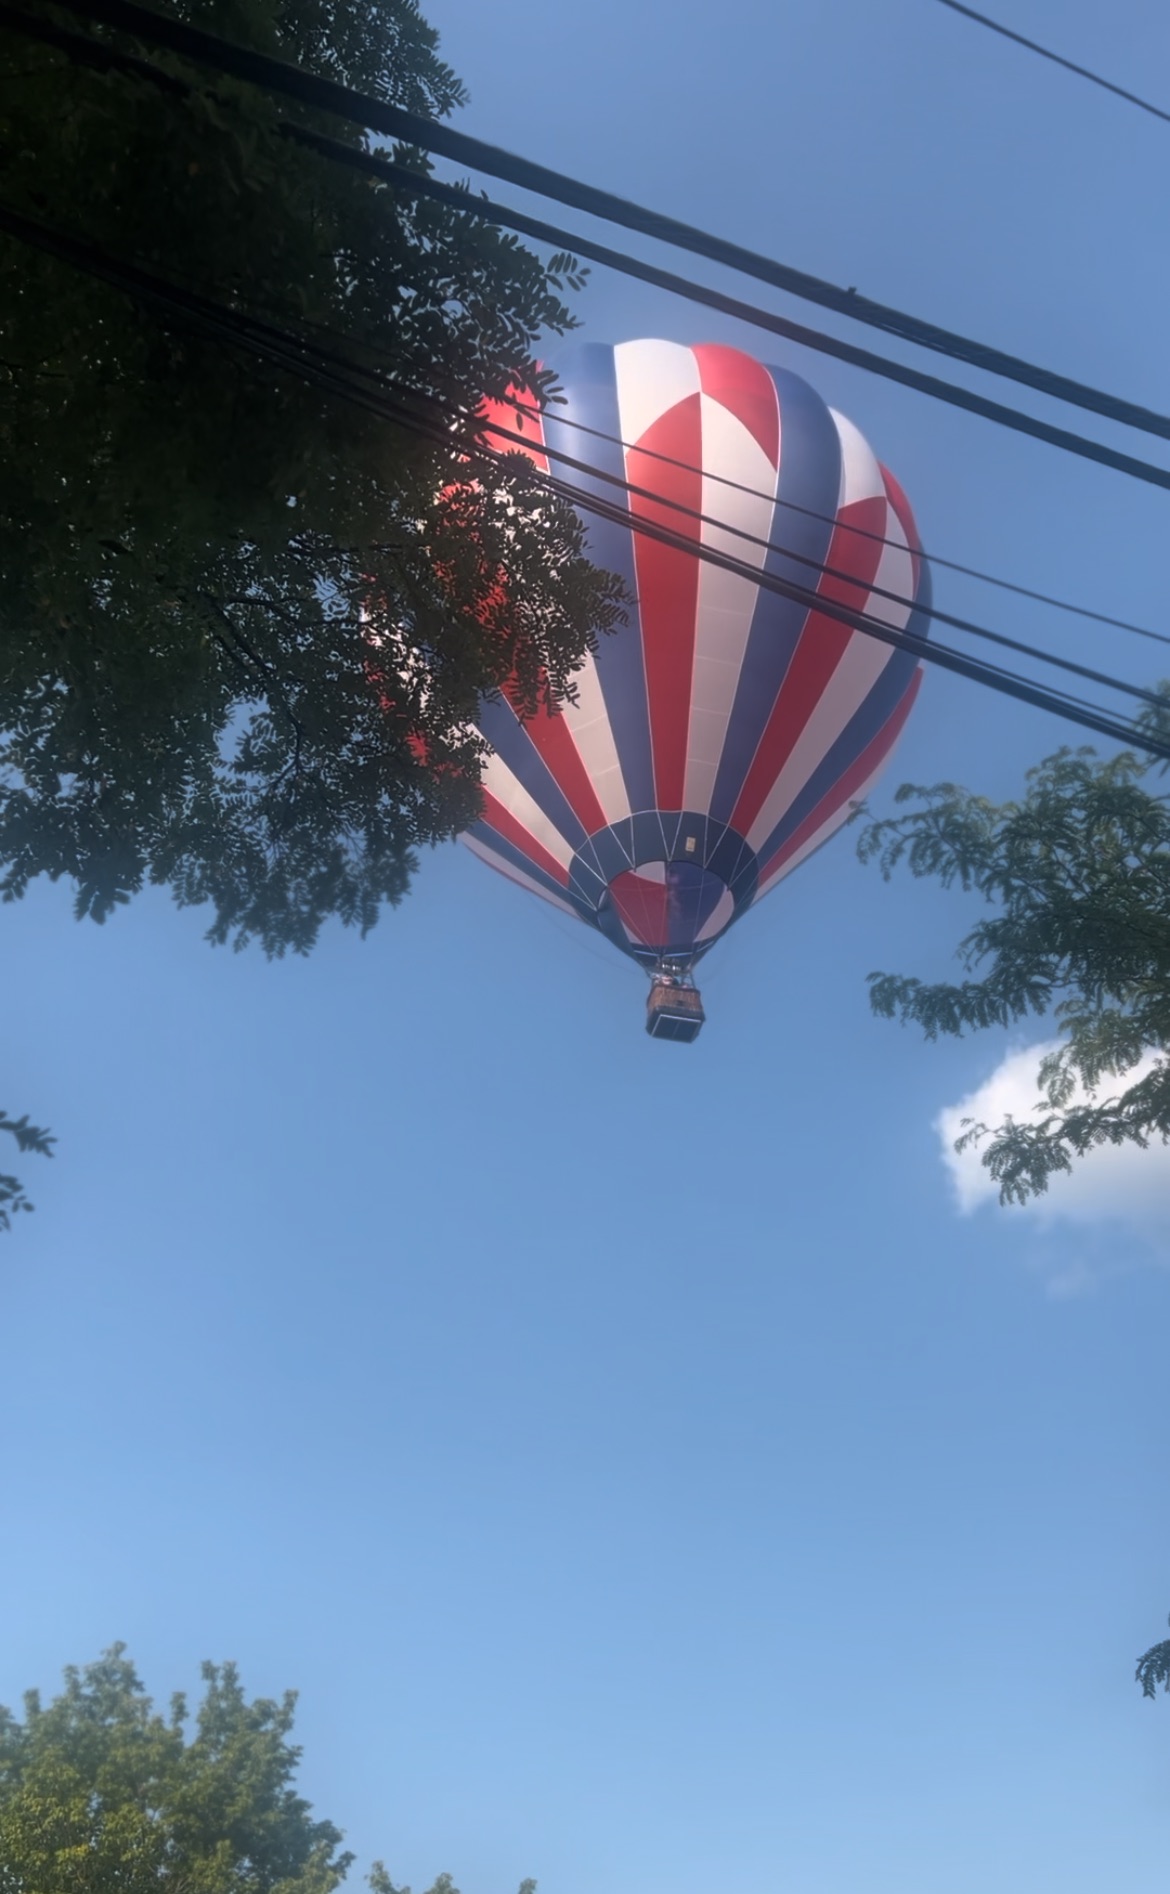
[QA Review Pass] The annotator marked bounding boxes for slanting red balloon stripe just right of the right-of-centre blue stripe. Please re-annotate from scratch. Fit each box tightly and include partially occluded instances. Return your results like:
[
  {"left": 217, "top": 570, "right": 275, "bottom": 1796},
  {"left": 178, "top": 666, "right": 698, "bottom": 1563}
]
[{"left": 731, "top": 498, "right": 886, "bottom": 835}]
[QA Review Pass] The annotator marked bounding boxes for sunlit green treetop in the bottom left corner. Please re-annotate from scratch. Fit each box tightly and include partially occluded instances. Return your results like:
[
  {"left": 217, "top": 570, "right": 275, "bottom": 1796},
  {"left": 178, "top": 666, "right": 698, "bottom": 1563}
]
[{"left": 0, "top": 1644, "right": 514, "bottom": 1894}]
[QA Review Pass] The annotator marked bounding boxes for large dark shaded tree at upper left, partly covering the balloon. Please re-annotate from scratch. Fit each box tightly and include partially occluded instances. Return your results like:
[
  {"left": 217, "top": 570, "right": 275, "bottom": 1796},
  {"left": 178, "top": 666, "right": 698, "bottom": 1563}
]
[{"left": 0, "top": 0, "right": 619, "bottom": 955}]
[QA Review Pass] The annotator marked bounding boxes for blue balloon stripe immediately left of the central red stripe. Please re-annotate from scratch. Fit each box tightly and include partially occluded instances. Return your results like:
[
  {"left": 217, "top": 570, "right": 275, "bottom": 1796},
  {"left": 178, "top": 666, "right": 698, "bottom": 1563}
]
[{"left": 545, "top": 343, "right": 655, "bottom": 809}]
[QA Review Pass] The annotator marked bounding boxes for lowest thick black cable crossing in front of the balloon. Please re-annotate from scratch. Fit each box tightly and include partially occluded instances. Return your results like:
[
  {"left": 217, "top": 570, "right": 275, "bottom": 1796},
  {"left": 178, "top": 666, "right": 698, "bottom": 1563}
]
[{"left": 0, "top": 188, "right": 1170, "bottom": 759}]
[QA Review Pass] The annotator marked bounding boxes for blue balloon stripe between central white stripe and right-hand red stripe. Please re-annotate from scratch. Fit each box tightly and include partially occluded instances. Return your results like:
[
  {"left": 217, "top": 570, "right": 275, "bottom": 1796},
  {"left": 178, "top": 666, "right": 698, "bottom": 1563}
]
[{"left": 710, "top": 367, "right": 841, "bottom": 829}]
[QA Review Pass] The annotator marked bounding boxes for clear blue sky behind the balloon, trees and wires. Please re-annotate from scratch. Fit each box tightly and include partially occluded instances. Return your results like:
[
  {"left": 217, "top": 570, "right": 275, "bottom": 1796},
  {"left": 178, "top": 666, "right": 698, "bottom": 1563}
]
[{"left": 0, "top": 0, "right": 1170, "bottom": 1894}]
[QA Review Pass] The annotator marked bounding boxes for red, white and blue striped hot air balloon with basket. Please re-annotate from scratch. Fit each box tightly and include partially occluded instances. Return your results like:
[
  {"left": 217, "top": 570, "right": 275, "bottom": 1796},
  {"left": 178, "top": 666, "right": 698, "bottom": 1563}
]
[{"left": 462, "top": 341, "right": 930, "bottom": 1040}]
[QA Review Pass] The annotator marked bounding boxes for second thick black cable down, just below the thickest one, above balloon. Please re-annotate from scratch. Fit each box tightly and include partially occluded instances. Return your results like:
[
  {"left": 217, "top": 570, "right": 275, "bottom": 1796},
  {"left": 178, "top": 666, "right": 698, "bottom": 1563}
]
[{"left": 13, "top": 0, "right": 1170, "bottom": 491}]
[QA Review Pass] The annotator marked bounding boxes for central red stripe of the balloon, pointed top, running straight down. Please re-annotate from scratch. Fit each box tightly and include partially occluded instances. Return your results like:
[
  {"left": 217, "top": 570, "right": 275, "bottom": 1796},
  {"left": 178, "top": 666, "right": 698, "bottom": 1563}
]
[{"left": 627, "top": 394, "right": 702, "bottom": 809}]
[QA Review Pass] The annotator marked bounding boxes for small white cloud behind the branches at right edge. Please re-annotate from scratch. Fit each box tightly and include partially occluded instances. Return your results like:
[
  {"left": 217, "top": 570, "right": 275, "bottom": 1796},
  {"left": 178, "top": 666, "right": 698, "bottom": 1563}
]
[{"left": 935, "top": 1042, "right": 1170, "bottom": 1260}]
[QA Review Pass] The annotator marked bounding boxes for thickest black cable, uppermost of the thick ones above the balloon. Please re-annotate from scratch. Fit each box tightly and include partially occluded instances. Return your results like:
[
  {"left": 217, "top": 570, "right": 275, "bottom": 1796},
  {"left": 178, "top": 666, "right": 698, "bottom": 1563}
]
[{"left": 36, "top": 0, "right": 1170, "bottom": 439}]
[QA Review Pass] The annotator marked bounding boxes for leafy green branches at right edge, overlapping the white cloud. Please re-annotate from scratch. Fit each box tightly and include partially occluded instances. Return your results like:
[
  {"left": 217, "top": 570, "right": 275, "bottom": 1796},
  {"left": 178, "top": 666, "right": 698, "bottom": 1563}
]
[{"left": 860, "top": 686, "right": 1170, "bottom": 1203}]
